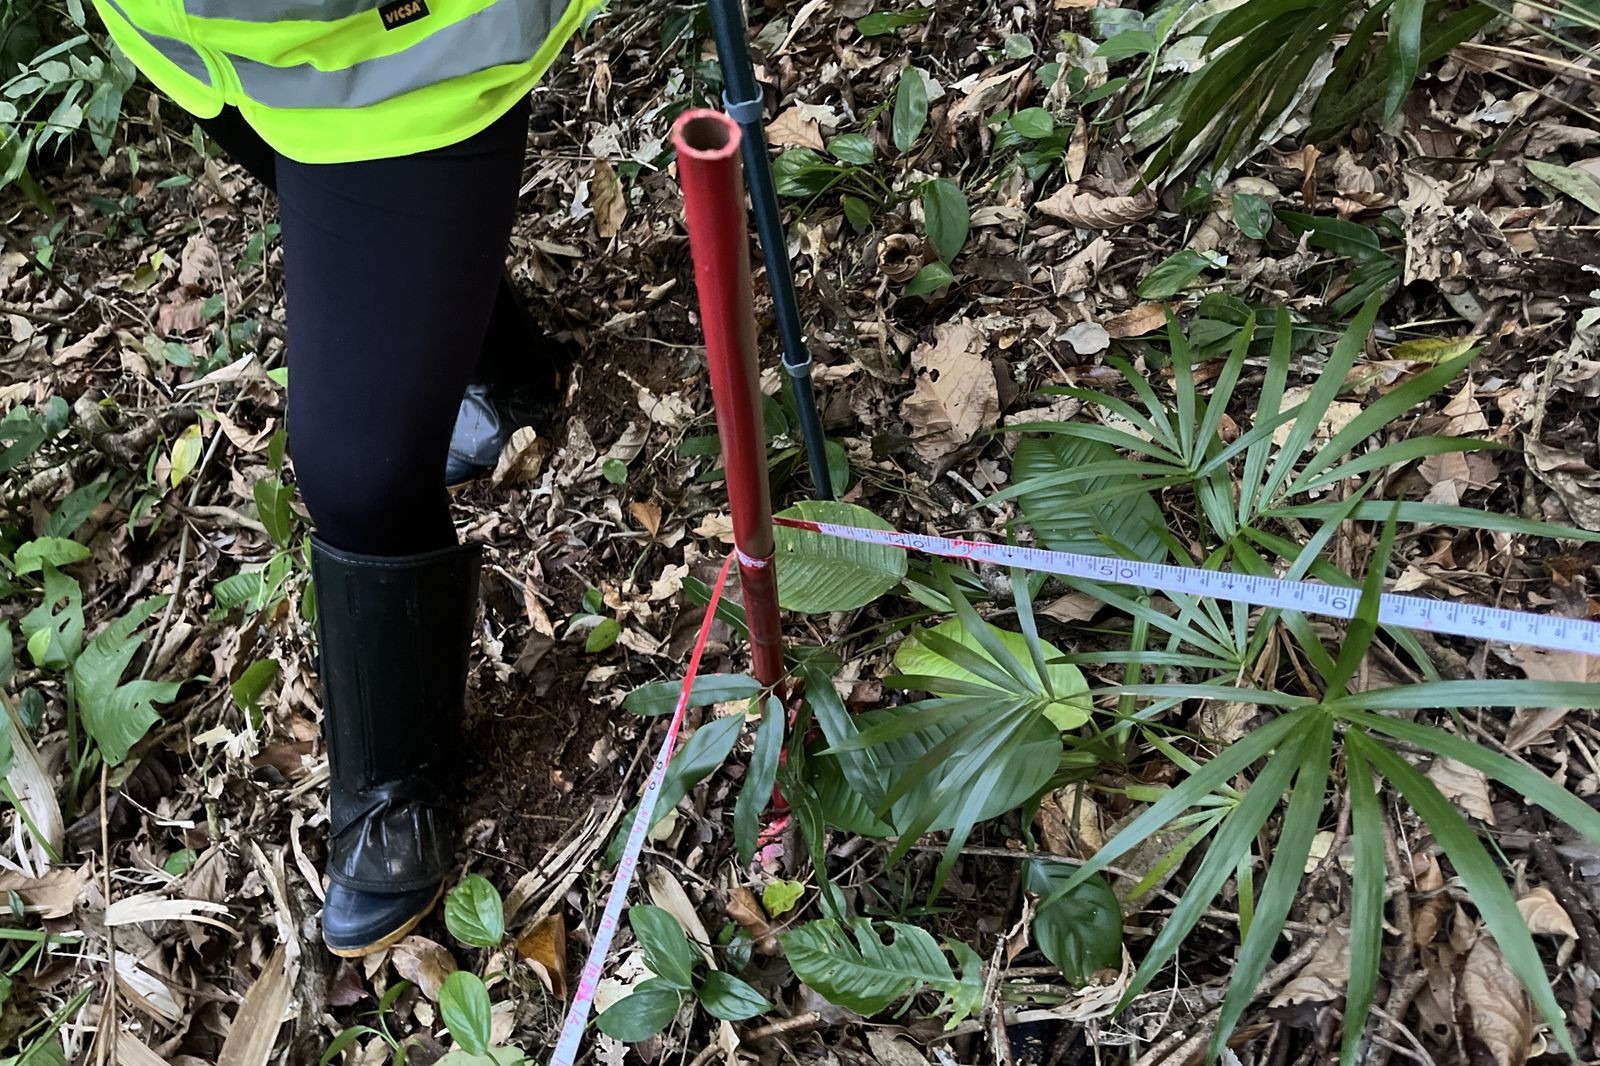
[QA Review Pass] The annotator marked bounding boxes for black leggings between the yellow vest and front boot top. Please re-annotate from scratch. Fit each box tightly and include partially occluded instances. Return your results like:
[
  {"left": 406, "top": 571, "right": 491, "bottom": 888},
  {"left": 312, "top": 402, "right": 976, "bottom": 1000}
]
[{"left": 202, "top": 101, "right": 530, "bottom": 555}]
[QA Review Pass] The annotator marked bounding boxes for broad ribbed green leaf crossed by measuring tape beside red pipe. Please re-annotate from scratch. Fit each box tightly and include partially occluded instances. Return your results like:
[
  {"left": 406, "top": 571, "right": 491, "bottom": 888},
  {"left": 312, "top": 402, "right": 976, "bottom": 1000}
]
[{"left": 773, "top": 499, "right": 906, "bottom": 615}]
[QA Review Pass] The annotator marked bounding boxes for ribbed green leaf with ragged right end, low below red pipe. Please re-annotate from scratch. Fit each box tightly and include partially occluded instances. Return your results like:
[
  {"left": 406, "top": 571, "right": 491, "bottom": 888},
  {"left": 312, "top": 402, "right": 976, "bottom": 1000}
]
[{"left": 778, "top": 919, "right": 982, "bottom": 1024}]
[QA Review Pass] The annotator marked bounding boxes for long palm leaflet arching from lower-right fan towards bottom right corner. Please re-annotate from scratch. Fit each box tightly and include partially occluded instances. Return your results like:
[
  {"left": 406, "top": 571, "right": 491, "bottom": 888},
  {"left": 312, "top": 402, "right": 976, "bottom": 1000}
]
[{"left": 1346, "top": 731, "right": 1578, "bottom": 1058}]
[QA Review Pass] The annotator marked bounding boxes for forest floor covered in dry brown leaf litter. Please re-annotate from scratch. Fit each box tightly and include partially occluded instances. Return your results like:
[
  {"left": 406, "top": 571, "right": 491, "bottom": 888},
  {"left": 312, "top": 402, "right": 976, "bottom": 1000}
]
[{"left": 0, "top": 0, "right": 1600, "bottom": 1066}]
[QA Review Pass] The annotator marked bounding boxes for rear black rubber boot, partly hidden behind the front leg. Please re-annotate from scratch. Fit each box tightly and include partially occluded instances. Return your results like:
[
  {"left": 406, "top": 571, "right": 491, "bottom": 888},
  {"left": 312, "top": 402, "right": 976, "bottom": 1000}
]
[{"left": 445, "top": 277, "right": 573, "bottom": 487}]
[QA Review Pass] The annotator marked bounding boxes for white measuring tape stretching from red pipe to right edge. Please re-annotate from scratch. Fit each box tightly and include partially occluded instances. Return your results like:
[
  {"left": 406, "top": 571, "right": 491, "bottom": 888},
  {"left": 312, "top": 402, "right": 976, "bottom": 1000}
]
[{"left": 773, "top": 519, "right": 1600, "bottom": 655}]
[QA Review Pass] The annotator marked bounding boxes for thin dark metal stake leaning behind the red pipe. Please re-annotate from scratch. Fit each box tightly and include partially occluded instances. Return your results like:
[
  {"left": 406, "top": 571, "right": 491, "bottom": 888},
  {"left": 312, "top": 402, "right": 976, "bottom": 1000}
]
[{"left": 707, "top": 0, "right": 834, "bottom": 499}]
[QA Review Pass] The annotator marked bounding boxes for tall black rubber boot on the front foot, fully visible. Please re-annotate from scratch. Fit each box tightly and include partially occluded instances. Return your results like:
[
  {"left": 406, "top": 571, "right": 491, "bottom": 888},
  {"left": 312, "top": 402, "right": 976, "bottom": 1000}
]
[{"left": 312, "top": 538, "right": 478, "bottom": 957}]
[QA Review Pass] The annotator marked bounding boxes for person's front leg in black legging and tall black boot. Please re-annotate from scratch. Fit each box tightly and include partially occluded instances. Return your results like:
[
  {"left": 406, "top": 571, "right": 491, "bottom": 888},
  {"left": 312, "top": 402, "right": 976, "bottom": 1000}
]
[{"left": 277, "top": 95, "right": 528, "bottom": 956}]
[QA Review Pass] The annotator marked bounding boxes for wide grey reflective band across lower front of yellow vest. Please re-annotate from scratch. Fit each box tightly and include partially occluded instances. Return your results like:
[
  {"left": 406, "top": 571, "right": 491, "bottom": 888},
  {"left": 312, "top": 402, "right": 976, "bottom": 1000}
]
[{"left": 229, "top": 0, "right": 568, "bottom": 107}]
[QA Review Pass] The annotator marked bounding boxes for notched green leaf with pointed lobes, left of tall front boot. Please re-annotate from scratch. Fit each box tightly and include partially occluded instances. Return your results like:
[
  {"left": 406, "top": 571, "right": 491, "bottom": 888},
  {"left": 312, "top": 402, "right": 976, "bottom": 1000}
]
[{"left": 72, "top": 595, "right": 179, "bottom": 765}]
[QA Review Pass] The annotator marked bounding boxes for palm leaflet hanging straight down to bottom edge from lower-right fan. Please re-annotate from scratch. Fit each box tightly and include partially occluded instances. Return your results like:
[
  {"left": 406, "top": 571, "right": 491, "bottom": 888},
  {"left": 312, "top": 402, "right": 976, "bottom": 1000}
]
[{"left": 1339, "top": 744, "right": 1389, "bottom": 1066}]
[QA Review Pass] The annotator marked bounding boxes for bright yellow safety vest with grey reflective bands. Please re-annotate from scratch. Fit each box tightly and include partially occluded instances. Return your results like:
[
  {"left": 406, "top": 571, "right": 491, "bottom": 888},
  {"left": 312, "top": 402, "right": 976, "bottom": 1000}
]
[{"left": 94, "top": 0, "right": 605, "bottom": 163}]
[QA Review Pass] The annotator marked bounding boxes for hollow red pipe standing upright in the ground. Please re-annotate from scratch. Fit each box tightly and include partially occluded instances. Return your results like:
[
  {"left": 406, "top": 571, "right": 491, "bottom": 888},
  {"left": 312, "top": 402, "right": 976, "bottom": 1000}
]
[{"left": 672, "top": 110, "right": 784, "bottom": 685}]
